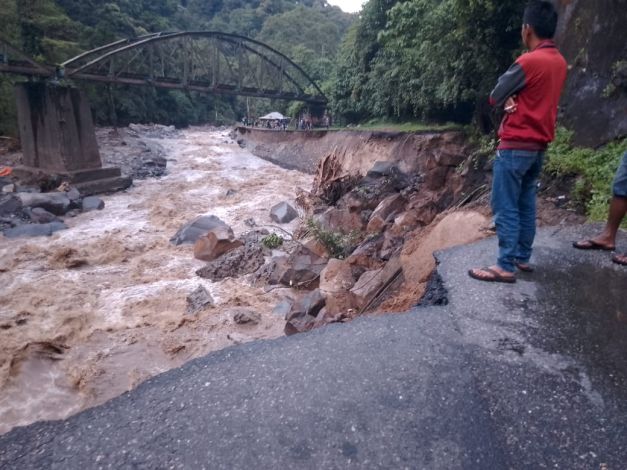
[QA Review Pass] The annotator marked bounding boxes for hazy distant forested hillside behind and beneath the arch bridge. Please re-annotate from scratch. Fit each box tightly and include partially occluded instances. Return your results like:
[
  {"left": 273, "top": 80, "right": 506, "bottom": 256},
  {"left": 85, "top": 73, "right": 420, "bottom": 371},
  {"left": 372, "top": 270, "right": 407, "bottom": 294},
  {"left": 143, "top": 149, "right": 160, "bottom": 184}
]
[{"left": 0, "top": 0, "right": 355, "bottom": 134}]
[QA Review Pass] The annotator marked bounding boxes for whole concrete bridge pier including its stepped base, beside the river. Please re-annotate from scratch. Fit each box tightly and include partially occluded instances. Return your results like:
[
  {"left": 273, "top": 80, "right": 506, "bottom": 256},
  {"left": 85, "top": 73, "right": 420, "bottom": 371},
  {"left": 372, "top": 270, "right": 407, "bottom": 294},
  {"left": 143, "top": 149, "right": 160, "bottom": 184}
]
[{"left": 15, "top": 82, "right": 132, "bottom": 196}]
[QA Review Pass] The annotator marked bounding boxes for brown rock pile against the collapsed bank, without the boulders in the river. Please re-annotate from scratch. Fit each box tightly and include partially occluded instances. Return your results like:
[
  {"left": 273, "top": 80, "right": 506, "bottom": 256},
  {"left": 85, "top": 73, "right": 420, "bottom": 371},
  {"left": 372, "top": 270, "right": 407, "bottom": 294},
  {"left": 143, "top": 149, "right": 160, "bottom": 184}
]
[{"left": 269, "top": 154, "right": 485, "bottom": 334}]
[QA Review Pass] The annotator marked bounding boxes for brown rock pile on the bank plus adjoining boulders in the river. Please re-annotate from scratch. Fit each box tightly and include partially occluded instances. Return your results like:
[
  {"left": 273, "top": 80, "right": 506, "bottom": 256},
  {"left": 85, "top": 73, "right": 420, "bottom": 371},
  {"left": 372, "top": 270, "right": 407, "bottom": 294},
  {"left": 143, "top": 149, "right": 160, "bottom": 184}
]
[{"left": 178, "top": 147, "right": 485, "bottom": 335}]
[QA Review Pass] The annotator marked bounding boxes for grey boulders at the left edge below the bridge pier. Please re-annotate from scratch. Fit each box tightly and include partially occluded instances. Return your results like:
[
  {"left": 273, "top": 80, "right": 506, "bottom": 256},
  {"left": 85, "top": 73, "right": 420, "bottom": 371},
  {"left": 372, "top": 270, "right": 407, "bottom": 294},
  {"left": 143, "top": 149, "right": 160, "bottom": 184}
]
[{"left": 0, "top": 181, "right": 104, "bottom": 238}]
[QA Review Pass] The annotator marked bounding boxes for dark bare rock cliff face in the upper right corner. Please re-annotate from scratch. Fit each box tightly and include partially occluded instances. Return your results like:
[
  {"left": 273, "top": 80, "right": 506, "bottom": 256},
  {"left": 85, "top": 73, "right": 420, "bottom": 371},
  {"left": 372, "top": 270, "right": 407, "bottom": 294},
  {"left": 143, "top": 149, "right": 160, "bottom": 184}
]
[{"left": 556, "top": 0, "right": 627, "bottom": 147}]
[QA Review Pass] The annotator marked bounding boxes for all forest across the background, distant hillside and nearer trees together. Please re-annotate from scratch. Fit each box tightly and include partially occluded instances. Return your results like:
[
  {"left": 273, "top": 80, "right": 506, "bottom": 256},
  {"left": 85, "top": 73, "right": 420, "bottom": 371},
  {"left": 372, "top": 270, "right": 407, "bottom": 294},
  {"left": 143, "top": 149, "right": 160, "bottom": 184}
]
[{"left": 0, "top": 0, "right": 524, "bottom": 133}]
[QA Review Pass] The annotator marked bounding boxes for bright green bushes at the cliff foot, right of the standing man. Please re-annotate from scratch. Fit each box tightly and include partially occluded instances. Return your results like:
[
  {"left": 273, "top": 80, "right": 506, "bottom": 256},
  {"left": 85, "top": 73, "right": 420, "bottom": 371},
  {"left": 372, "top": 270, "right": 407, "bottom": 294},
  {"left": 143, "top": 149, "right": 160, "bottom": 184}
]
[{"left": 545, "top": 128, "right": 627, "bottom": 221}]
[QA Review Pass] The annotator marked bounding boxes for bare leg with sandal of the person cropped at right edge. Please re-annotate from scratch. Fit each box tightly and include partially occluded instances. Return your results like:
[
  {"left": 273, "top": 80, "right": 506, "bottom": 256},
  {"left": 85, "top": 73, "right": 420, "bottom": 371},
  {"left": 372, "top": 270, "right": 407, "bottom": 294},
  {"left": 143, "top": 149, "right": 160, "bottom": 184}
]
[{"left": 574, "top": 152, "right": 627, "bottom": 249}]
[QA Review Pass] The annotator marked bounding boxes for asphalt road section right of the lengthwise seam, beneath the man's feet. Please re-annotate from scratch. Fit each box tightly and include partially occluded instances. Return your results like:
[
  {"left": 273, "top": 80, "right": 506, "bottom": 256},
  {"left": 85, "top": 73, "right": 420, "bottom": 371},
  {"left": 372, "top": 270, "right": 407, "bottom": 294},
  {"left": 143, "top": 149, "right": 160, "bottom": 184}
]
[{"left": 439, "top": 227, "right": 627, "bottom": 469}]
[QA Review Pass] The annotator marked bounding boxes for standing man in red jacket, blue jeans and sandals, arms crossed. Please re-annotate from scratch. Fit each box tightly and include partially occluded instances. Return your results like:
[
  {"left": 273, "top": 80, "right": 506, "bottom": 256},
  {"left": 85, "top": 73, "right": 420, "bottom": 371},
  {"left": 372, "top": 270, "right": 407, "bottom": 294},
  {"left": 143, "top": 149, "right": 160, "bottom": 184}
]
[{"left": 468, "top": 0, "right": 567, "bottom": 283}]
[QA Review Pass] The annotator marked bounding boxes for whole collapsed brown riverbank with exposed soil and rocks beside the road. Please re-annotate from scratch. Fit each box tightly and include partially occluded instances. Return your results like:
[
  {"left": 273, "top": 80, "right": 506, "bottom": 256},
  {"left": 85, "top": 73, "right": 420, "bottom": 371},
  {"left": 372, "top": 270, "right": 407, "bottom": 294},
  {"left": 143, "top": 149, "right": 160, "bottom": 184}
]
[{"left": 235, "top": 128, "right": 584, "bottom": 334}]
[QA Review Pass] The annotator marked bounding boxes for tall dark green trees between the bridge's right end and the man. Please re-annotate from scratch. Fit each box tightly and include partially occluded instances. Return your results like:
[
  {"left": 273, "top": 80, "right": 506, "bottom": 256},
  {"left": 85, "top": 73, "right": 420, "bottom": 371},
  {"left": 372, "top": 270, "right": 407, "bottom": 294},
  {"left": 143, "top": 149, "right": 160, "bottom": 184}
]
[{"left": 333, "top": 0, "right": 523, "bottom": 123}]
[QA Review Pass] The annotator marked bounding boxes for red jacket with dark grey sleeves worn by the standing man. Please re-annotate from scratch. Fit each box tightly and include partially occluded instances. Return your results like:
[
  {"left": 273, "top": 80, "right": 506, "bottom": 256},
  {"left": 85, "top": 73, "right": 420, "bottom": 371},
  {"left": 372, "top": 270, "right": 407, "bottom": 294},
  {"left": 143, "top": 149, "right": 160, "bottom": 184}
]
[{"left": 490, "top": 40, "right": 567, "bottom": 150}]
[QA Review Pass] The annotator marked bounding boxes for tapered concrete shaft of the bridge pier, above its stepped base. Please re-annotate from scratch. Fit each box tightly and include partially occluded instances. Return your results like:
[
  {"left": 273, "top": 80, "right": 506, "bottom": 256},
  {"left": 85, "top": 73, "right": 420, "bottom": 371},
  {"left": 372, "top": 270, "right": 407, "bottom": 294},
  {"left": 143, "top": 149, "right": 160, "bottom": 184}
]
[{"left": 15, "top": 83, "right": 102, "bottom": 173}]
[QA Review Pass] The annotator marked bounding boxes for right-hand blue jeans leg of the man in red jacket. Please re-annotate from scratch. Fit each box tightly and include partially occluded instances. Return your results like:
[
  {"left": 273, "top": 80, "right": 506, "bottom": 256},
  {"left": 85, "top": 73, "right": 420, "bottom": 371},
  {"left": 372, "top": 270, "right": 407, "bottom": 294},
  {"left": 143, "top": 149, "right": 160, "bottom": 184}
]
[{"left": 516, "top": 152, "right": 544, "bottom": 267}]
